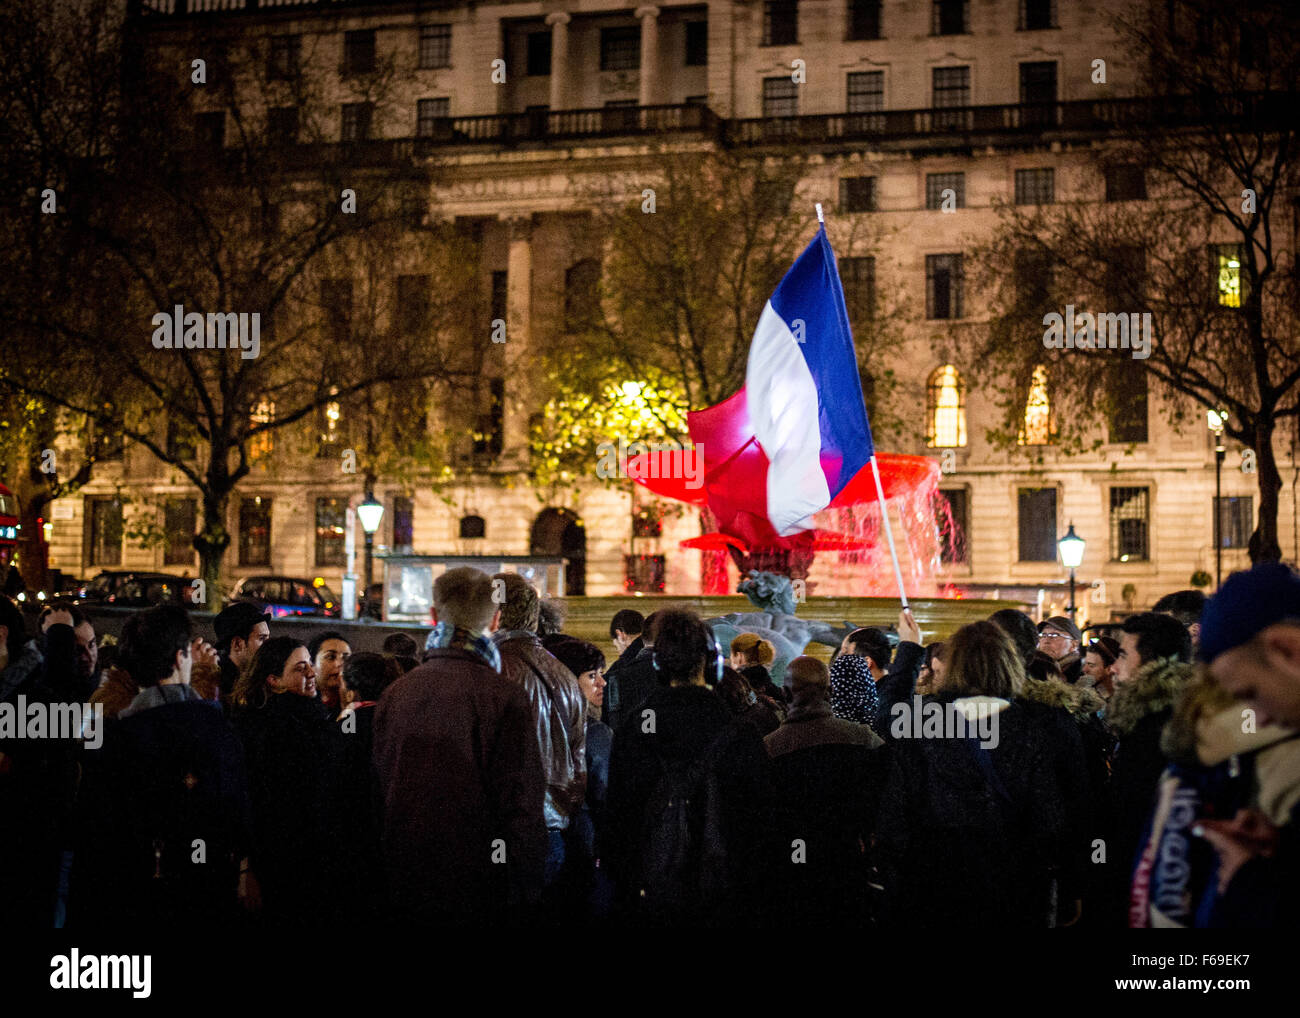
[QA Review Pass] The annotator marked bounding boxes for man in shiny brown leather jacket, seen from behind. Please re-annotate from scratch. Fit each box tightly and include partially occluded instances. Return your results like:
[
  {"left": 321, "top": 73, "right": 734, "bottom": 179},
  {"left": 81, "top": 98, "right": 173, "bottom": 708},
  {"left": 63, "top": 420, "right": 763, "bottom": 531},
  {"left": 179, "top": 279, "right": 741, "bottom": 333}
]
[{"left": 493, "top": 572, "right": 586, "bottom": 885}]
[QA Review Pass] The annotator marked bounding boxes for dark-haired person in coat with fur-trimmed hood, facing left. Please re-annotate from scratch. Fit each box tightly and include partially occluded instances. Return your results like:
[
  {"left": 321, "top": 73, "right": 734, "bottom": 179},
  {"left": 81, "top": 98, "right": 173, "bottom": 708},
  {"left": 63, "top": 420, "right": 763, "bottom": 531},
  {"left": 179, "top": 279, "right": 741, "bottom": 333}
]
[{"left": 1105, "top": 611, "right": 1192, "bottom": 926}]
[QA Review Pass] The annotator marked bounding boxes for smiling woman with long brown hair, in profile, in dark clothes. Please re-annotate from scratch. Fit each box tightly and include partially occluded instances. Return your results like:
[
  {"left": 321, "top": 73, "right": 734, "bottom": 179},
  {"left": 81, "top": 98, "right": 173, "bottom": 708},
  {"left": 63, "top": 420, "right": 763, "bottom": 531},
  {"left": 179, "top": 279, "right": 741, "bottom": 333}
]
[{"left": 231, "top": 636, "right": 346, "bottom": 926}]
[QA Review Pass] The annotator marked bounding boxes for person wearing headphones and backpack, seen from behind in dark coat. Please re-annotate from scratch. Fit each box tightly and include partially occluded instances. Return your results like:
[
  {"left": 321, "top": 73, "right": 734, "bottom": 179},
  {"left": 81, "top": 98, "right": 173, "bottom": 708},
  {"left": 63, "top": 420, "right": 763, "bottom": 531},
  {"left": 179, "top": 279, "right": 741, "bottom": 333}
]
[{"left": 607, "top": 610, "right": 771, "bottom": 926}]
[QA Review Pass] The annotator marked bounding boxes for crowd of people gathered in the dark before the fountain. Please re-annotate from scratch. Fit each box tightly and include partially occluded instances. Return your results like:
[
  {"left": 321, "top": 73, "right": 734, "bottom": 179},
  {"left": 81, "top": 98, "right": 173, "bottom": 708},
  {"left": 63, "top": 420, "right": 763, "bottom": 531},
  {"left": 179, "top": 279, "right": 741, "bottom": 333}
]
[{"left": 0, "top": 564, "right": 1300, "bottom": 930}]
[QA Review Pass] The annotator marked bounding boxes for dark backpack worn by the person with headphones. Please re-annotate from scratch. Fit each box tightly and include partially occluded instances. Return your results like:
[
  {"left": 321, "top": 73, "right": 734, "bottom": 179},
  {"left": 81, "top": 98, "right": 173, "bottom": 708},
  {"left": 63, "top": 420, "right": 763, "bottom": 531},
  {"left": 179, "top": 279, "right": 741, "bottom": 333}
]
[{"left": 637, "top": 727, "right": 732, "bottom": 923}]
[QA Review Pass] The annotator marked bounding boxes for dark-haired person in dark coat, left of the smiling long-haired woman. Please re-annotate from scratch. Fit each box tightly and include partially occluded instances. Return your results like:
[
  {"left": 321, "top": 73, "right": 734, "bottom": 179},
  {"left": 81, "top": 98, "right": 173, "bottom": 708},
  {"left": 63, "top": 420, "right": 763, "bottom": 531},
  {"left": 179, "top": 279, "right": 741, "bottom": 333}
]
[{"left": 69, "top": 606, "right": 250, "bottom": 933}]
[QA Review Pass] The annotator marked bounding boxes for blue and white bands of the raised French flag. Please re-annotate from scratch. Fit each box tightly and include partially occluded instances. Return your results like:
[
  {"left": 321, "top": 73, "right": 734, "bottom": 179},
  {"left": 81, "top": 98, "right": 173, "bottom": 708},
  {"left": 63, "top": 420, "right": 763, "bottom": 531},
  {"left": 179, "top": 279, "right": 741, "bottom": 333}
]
[{"left": 745, "top": 226, "right": 874, "bottom": 537}]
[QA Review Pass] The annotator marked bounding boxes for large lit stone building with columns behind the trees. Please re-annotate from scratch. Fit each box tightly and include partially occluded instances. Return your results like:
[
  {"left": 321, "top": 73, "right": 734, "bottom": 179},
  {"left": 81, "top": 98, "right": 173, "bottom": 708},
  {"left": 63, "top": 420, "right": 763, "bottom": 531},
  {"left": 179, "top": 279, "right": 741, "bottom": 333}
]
[{"left": 51, "top": 0, "right": 1300, "bottom": 619}]
